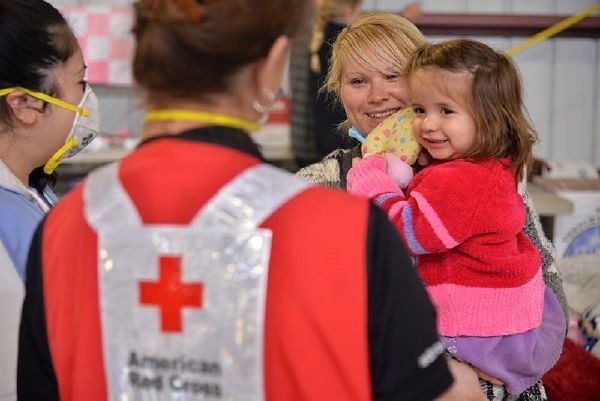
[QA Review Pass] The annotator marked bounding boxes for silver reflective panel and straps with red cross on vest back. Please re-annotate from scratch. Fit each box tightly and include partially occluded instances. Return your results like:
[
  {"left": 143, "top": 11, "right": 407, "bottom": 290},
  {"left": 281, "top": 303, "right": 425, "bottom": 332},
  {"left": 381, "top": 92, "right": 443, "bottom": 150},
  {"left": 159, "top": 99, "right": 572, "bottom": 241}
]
[{"left": 84, "top": 164, "right": 307, "bottom": 401}]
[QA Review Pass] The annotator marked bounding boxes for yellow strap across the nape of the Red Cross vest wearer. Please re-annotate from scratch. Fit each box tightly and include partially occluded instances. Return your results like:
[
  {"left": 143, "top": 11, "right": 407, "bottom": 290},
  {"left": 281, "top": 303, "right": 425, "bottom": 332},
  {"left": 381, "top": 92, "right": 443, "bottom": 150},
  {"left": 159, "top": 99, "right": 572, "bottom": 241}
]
[{"left": 146, "top": 109, "right": 260, "bottom": 132}]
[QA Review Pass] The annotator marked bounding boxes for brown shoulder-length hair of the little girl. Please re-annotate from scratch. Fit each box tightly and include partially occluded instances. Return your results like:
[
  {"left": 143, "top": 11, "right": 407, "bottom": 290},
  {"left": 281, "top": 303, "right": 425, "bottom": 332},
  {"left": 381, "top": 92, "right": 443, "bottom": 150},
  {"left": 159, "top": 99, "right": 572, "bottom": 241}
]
[{"left": 405, "top": 39, "right": 537, "bottom": 180}]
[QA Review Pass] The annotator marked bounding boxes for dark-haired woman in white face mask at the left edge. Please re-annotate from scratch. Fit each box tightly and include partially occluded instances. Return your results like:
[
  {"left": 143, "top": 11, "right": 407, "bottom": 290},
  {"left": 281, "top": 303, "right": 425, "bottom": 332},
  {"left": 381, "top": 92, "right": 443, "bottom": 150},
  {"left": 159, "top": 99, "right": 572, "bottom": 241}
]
[{"left": 0, "top": 0, "right": 98, "bottom": 401}]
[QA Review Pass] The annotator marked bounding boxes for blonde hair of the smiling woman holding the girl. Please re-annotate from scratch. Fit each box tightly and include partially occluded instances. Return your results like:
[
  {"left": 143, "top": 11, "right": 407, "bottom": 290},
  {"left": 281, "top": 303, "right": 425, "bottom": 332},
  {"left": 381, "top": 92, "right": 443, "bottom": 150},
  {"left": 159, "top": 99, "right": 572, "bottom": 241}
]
[{"left": 323, "top": 12, "right": 426, "bottom": 99}]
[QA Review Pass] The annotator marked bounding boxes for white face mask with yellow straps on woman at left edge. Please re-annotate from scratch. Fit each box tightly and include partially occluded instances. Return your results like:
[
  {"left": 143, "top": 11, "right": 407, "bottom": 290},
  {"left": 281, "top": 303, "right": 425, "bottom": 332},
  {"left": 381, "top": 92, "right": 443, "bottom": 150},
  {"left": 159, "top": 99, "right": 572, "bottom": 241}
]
[{"left": 0, "top": 85, "right": 100, "bottom": 174}]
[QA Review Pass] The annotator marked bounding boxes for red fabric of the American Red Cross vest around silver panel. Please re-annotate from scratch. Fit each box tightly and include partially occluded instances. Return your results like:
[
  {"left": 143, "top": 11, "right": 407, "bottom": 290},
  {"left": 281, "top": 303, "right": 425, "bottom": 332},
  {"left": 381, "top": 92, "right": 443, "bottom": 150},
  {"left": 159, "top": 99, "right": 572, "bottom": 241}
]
[{"left": 42, "top": 139, "right": 371, "bottom": 401}]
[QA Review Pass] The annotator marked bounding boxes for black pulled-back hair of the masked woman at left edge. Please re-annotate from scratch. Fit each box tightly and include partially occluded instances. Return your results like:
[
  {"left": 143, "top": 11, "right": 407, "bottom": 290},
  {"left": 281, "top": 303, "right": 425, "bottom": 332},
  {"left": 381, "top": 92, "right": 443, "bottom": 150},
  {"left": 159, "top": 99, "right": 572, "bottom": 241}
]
[{"left": 0, "top": 0, "right": 79, "bottom": 187}]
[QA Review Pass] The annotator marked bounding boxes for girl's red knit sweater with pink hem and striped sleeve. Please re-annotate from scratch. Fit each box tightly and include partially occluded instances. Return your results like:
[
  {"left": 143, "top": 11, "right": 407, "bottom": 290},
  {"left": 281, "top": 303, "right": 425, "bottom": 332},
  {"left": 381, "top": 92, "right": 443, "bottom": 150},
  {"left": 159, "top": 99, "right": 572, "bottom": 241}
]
[{"left": 364, "top": 159, "right": 544, "bottom": 337}]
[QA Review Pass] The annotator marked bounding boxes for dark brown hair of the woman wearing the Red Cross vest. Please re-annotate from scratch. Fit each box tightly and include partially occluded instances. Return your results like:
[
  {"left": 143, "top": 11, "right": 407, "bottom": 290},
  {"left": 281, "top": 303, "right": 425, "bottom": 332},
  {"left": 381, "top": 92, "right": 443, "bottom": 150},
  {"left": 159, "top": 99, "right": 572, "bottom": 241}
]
[{"left": 133, "top": 0, "right": 309, "bottom": 102}]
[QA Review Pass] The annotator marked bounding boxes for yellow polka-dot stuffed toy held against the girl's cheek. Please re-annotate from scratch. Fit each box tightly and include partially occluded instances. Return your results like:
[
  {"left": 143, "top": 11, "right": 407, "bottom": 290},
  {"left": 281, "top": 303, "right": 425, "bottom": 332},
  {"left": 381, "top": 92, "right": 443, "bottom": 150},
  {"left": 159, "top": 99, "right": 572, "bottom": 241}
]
[{"left": 361, "top": 108, "right": 421, "bottom": 188}]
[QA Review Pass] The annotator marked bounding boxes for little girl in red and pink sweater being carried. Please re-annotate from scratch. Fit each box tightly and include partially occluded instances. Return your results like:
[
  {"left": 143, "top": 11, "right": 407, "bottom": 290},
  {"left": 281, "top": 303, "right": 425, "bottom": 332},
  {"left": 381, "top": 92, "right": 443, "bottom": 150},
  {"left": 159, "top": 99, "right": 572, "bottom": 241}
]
[{"left": 348, "top": 36, "right": 565, "bottom": 399}]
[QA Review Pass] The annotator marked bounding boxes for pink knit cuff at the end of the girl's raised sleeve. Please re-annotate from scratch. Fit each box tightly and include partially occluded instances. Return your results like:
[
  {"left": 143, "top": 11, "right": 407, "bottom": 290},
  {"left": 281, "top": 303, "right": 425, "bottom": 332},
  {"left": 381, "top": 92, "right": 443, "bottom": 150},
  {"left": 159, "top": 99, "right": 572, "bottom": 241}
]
[{"left": 346, "top": 155, "right": 402, "bottom": 198}]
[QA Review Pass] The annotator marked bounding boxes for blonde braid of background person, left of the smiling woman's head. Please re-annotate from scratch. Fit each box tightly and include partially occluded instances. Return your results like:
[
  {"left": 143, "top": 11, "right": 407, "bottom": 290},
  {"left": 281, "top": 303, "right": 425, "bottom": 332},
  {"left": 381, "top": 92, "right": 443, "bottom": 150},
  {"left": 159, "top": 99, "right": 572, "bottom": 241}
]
[{"left": 309, "top": 0, "right": 363, "bottom": 73}]
